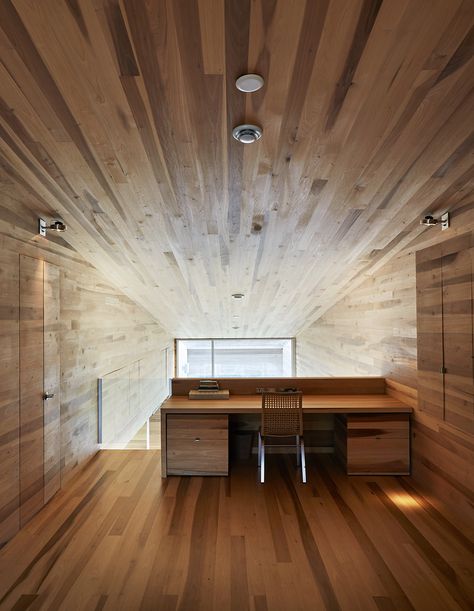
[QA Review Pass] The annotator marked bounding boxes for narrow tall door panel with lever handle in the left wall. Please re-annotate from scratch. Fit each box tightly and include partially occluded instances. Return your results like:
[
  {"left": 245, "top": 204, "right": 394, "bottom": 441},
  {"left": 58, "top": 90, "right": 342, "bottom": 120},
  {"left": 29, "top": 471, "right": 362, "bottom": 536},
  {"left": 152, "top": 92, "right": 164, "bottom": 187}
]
[{"left": 43, "top": 262, "right": 61, "bottom": 503}]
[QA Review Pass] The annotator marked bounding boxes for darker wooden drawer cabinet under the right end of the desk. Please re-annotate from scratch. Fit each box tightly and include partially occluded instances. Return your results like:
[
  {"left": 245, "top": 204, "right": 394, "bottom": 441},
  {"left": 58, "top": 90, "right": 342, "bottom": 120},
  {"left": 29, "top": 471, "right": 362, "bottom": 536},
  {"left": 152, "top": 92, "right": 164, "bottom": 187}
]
[{"left": 335, "top": 414, "right": 410, "bottom": 475}]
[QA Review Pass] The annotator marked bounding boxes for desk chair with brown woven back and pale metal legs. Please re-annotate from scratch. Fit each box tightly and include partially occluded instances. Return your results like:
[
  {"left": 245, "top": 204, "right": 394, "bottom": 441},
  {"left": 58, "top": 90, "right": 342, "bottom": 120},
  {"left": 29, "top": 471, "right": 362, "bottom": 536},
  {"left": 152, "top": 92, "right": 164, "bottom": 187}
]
[{"left": 258, "top": 391, "right": 306, "bottom": 484}]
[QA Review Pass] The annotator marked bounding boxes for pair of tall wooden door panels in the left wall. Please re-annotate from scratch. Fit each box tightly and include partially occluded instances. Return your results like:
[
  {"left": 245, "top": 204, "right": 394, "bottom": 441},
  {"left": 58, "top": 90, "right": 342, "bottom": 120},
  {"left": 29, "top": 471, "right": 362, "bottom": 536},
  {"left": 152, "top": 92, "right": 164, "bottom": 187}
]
[{"left": 19, "top": 255, "right": 61, "bottom": 526}]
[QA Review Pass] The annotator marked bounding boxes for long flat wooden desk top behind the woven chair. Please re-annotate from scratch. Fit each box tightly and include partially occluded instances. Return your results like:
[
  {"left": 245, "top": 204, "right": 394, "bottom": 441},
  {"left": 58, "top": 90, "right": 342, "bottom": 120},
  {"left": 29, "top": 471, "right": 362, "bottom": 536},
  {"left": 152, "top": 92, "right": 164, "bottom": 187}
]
[{"left": 161, "top": 394, "right": 413, "bottom": 414}]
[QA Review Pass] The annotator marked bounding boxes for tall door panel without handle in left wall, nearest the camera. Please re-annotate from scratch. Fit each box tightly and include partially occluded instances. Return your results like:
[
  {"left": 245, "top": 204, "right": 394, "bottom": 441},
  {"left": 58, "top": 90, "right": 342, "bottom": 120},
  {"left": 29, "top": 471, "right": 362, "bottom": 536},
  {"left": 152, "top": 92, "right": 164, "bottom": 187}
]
[{"left": 20, "top": 256, "right": 44, "bottom": 526}]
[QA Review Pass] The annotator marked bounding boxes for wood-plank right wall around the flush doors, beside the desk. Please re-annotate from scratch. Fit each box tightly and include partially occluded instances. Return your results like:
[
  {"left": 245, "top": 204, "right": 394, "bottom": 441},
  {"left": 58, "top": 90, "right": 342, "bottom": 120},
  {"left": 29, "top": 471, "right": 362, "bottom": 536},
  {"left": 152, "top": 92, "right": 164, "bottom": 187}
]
[{"left": 296, "top": 202, "right": 474, "bottom": 524}]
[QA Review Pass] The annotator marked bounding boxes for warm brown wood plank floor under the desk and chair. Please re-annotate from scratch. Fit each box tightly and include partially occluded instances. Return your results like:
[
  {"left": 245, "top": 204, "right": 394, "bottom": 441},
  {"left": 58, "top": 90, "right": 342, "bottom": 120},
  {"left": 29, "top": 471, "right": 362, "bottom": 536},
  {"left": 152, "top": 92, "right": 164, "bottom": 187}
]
[{"left": 0, "top": 450, "right": 474, "bottom": 611}]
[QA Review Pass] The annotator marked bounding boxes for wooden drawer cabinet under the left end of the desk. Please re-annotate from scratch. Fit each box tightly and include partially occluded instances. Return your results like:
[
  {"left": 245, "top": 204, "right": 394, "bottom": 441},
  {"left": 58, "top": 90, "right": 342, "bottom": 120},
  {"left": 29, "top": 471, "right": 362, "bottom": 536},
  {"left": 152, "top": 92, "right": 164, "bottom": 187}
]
[{"left": 166, "top": 414, "right": 229, "bottom": 475}]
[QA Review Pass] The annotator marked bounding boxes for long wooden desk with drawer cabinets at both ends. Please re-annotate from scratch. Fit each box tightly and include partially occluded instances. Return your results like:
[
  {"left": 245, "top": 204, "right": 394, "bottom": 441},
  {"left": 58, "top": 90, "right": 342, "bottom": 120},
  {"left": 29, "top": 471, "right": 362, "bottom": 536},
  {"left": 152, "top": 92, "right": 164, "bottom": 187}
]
[{"left": 161, "top": 394, "right": 413, "bottom": 477}]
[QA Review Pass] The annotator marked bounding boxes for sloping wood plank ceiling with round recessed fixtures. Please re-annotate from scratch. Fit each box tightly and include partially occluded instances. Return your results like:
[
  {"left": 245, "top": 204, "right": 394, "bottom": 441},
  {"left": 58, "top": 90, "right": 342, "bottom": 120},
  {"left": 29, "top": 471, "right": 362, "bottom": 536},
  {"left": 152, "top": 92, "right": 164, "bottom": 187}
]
[{"left": 0, "top": 0, "right": 474, "bottom": 337}]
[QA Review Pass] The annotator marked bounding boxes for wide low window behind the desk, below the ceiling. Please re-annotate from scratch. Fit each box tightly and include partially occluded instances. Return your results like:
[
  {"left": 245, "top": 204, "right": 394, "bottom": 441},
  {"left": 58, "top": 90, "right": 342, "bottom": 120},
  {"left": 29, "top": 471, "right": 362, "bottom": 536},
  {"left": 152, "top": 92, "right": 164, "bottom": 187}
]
[{"left": 176, "top": 338, "right": 295, "bottom": 378}]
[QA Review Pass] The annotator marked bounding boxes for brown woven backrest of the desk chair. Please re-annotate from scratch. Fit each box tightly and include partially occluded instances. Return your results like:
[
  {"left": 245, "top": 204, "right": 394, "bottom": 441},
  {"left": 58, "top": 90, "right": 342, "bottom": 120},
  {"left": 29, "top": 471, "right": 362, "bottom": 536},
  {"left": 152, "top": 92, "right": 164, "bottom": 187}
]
[{"left": 261, "top": 391, "right": 303, "bottom": 437}]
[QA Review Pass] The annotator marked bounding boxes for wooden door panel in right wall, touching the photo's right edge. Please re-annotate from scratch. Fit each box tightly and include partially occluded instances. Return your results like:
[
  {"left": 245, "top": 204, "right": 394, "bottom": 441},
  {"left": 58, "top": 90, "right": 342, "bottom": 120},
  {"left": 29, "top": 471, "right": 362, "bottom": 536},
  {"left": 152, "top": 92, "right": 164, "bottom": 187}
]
[{"left": 442, "top": 248, "right": 474, "bottom": 433}]
